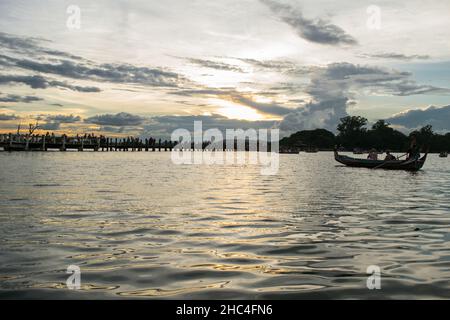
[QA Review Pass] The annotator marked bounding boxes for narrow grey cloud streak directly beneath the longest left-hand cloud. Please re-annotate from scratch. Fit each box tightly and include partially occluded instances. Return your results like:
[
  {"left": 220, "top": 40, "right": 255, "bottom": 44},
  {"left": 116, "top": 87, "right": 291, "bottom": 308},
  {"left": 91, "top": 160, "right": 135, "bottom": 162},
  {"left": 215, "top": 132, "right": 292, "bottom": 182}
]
[{"left": 0, "top": 75, "right": 101, "bottom": 92}]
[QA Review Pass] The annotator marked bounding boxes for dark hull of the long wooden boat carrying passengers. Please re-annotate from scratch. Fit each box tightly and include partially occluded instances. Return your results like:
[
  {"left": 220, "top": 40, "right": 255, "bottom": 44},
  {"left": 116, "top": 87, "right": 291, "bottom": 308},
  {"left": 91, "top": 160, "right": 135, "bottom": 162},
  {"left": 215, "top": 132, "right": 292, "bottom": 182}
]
[{"left": 334, "top": 151, "right": 428, "bottom": 171}]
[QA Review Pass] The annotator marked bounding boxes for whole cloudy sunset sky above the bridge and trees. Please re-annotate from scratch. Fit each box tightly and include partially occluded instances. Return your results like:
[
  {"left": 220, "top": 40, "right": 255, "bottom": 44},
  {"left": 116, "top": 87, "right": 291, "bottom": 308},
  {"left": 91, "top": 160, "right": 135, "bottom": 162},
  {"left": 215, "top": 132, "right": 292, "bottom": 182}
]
[{"left": 0, "top": 0, "right": 450, "bottom": 136}]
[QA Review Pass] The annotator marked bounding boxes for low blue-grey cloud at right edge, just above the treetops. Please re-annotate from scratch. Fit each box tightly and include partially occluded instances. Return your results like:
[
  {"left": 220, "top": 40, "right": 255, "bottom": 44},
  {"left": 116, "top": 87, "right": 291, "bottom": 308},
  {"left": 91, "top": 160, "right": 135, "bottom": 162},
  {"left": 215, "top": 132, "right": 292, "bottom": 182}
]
[{"left": 387, "top": 105, "right": 450, "bottom": 131}]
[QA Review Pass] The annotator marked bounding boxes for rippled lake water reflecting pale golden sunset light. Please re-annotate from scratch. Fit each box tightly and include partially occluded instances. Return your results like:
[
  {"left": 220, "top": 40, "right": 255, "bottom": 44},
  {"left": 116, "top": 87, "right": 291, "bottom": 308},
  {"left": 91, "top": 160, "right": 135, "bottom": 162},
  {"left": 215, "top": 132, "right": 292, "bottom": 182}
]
[{"left": 0, "top": 152, "right": 450, "bottom": 299}]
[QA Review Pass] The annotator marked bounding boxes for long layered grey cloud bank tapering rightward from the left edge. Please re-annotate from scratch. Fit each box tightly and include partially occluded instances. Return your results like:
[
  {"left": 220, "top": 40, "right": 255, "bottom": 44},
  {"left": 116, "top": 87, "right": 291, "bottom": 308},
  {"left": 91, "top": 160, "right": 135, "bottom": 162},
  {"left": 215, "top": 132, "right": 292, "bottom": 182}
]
[{"left": 0, "top": 33, "right": 190, "bottom": 99}]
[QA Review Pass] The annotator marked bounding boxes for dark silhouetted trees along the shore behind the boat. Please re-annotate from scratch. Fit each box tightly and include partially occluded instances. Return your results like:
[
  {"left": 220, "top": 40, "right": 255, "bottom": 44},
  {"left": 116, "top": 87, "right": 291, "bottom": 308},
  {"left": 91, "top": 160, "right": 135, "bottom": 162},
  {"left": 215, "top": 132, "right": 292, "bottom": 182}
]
[{"left": 280, "top": 116, "right": 450, "bottom": 152}]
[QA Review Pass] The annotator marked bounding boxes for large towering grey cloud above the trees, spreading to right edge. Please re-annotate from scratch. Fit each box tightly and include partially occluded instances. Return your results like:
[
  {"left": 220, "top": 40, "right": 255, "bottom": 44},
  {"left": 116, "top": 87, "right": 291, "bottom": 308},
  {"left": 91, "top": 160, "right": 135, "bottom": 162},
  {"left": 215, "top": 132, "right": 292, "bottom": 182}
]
[{"left": 279, "top": 63, "right": 450, "bottom": 132}]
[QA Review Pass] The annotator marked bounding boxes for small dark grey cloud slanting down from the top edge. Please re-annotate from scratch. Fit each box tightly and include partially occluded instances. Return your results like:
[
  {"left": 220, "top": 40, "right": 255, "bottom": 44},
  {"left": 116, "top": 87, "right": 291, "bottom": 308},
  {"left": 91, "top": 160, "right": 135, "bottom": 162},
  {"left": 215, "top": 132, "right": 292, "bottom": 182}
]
[{"left": 260, "top": 0, "right": 357, "bottom": 45}]
